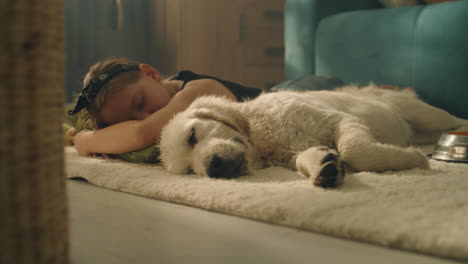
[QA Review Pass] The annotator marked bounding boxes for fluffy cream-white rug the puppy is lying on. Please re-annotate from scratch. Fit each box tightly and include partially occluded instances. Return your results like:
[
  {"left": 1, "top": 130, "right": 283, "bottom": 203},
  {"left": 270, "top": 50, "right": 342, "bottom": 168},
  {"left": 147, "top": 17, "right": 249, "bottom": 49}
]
[{"left": 66, "top": 147, "right": 468, "bottom": 260}]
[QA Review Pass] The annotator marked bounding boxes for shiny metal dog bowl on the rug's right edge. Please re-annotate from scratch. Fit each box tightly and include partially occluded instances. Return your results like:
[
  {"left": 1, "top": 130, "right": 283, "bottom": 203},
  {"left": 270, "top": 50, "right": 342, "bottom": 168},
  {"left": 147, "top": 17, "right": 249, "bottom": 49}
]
[{"left": 432, "top": 131, "right": 468, "bottom": 163}]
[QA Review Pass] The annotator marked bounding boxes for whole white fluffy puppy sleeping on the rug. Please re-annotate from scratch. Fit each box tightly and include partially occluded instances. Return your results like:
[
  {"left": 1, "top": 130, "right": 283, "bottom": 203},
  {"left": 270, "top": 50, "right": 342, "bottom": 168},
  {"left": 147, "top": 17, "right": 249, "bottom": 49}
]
[{"left": 160, "top": 85, "right": 468, "bottom": 188}]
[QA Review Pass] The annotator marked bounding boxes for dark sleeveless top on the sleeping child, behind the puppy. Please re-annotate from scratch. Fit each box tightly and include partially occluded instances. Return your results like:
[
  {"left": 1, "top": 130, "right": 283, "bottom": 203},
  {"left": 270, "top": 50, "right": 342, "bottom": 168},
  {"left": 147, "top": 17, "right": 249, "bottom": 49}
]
[{"left": 172, "top": 71, "right": 263, "bottom": 102}]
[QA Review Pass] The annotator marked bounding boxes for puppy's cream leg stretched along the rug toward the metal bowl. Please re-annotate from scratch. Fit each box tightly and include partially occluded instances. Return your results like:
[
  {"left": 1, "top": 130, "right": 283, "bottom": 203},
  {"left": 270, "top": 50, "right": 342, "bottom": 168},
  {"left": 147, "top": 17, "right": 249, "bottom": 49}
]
[{"left": 335, "top": 117, "right": 429, "bottom": 171}]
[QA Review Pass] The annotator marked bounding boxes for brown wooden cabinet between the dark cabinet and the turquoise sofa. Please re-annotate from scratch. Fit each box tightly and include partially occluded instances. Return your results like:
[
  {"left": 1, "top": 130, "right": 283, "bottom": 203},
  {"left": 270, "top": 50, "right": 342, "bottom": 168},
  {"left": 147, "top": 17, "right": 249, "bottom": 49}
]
[{"left": 153, "top": 0, "right": 285, "bottom": 89}]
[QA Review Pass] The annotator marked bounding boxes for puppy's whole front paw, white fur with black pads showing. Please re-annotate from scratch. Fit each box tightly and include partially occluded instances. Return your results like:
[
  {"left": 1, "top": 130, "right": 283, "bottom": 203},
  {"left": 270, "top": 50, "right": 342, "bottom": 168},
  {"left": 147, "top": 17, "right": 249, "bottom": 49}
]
[{"left": 296, "top": 146, "right": 345, "bottom": 188}]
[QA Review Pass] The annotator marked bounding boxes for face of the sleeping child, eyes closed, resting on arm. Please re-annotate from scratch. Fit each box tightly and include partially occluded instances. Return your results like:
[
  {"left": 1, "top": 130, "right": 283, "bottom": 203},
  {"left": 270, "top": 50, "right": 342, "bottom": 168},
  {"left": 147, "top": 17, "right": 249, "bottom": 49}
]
[{"left": 98, "top": 76, "right": 171, "bottom": 125}]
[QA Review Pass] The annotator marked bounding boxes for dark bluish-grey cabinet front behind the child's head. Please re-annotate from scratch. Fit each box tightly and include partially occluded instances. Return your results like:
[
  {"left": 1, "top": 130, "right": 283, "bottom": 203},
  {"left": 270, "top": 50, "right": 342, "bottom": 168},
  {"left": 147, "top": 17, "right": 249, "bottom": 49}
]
[{"left": 65, "top": 0, "right": 154, "bottom": 101}]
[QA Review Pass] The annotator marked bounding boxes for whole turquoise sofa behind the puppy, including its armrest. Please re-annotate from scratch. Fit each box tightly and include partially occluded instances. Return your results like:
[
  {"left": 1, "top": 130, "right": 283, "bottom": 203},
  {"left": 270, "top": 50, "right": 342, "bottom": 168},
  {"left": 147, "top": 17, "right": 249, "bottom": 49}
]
[{"left": 285, "top": 0, "right": 468, "bottom": 118}]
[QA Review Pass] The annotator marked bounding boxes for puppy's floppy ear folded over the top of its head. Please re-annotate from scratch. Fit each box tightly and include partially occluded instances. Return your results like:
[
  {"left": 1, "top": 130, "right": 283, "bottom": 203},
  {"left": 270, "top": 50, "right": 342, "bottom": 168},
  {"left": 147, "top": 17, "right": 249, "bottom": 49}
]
[{"left": 193, "top": 108, "right": 250, "bottom": 138}]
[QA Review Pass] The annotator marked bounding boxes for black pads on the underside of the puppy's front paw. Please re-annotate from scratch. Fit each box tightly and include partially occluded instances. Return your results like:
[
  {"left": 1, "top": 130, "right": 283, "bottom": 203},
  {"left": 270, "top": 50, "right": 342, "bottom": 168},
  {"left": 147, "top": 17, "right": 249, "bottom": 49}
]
[{"left": 312, "top": 153, "right": 345, "bottom": 188}]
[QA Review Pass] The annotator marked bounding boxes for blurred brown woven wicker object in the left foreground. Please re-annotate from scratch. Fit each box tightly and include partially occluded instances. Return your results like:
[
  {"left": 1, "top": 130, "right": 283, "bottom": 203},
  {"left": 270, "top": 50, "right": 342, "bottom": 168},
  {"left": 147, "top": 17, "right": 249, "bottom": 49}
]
[{"left": 0, "top": 0, "right": 68, "bottom": 264}]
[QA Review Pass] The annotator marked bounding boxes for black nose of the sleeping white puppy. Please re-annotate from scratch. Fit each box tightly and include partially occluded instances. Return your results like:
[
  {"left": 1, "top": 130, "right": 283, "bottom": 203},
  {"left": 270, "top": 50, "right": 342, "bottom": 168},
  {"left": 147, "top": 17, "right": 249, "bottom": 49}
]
[{"left": 206, "top": 155, "right": 245, "bottom": 179}]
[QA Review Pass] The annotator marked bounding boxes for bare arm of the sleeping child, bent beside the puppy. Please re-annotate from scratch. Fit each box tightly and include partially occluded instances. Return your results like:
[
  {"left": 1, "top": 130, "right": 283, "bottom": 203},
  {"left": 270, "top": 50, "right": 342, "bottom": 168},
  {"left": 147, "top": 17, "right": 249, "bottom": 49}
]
[{"left": 75, "top": 79, "right": 236, "bottom": 156}]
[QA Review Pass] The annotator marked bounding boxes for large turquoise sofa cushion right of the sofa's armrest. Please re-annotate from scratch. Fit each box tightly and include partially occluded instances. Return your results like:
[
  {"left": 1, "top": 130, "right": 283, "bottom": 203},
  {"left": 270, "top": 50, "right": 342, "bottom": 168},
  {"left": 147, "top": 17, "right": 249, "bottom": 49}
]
[{"left": 315, "top": 1, "right": 468, "bottom": 118}]
